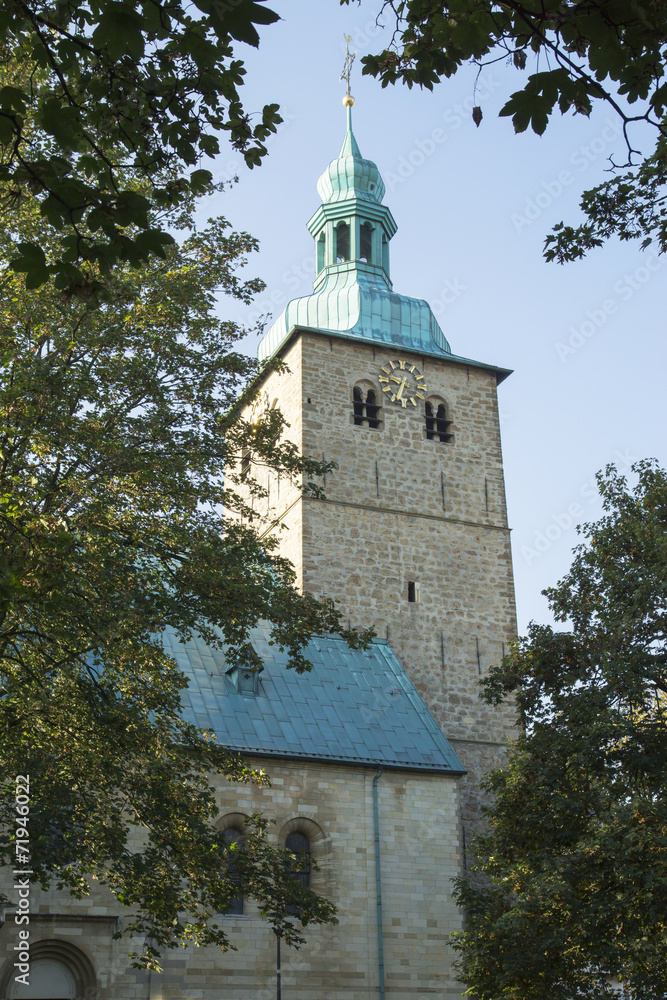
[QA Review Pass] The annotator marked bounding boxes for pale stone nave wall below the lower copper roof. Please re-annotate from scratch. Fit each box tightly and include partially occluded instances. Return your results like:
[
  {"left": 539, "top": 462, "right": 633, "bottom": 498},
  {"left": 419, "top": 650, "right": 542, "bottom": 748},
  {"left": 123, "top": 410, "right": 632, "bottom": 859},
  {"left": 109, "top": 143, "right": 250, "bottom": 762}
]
[{"left": 0, "top": 760, "right": 461, "bottom": 1000}]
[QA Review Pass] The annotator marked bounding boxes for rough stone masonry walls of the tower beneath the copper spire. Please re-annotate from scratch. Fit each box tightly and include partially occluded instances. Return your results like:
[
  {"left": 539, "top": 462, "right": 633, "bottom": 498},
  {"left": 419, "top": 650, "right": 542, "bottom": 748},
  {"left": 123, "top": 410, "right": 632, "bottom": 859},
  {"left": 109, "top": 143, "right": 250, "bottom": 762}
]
[{"left": 243, "top": 333, "right": 516, "bottom": 826}]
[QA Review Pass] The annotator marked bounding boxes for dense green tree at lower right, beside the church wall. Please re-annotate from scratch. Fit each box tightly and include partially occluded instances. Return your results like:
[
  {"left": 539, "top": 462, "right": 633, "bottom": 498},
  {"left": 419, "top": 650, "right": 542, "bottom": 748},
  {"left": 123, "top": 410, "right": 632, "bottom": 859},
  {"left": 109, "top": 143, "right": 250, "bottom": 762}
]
[{"left": 456, "top": 462, "right": 667, "bottom": 1000}]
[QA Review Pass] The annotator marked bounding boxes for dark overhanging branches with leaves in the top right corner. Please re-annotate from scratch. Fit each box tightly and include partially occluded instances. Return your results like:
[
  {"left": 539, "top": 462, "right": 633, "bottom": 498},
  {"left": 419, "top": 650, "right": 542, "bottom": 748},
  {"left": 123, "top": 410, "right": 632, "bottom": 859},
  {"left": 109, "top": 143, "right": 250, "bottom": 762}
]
[{"left": 348, "top": 0, "right": 667, "bottom": 263}]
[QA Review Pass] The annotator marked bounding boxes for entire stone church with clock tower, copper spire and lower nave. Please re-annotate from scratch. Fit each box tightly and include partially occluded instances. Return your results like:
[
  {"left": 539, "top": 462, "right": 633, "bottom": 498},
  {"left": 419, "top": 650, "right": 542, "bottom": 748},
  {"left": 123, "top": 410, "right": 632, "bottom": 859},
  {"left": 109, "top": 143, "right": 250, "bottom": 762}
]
[{"left": 0, "top": 98, "right": 515, "bottom": 1000}]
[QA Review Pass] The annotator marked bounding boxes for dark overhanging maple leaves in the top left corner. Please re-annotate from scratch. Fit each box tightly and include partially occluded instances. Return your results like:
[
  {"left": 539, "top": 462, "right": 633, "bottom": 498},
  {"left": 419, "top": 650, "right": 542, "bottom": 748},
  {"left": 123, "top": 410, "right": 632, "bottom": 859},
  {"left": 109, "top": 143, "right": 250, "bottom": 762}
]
[{"left": 0, "top": 0, "right": 281, "bottom": 295}]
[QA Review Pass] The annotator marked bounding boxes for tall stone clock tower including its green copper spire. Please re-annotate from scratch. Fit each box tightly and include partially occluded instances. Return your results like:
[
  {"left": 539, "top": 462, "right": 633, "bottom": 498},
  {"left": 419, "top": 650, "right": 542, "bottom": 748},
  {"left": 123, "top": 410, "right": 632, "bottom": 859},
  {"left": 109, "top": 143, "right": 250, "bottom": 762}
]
[{"left": 243, "top": 98, "right": 516, "bottom": 844}]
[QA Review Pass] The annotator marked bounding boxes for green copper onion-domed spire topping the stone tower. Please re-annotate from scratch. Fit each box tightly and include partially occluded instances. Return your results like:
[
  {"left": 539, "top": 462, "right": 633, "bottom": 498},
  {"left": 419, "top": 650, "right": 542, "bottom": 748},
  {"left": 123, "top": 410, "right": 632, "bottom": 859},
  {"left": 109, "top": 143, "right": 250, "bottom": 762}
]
[{"left": 258, "top": 100, "right": 451, "bottom": 358}]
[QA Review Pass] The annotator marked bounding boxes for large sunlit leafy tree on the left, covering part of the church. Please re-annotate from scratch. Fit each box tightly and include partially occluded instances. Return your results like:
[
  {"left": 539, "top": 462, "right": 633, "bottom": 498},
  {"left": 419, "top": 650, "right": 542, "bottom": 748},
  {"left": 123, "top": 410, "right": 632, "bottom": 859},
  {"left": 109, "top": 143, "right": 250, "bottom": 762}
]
[{"left": 0, "top": 188, "right": 364, "bottom": 966}]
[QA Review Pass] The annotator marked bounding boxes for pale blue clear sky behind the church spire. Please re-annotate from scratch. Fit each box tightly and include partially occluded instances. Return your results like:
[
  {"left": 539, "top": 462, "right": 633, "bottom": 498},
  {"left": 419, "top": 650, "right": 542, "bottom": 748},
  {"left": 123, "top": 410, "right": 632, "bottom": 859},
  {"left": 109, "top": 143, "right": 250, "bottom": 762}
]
[{"left": 210, "top": 0, "right": 667, "bottom": 631}]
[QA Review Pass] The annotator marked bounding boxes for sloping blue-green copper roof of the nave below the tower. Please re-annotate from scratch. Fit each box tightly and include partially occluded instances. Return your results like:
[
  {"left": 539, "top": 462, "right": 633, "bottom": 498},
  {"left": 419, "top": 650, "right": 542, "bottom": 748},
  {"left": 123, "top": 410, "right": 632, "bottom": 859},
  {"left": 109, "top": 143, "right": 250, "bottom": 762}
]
[{"left": 170, "top": 625, "right": 464, "bottom": 774}]
